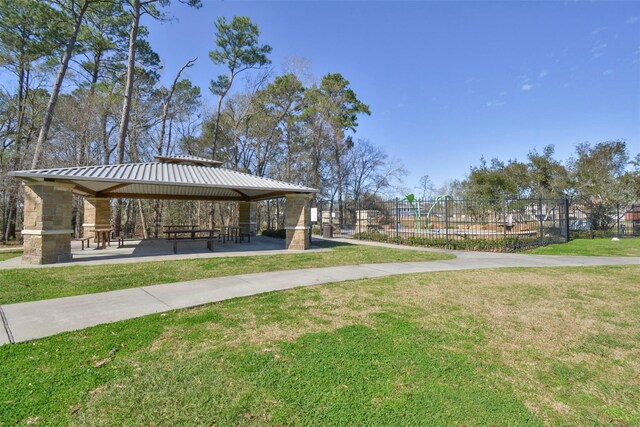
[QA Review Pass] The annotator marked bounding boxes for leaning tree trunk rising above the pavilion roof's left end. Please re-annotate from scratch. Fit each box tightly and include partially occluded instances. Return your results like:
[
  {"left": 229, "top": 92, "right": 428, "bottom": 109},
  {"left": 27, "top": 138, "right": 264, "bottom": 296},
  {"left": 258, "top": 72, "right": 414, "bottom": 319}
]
[{"left": 31, "top": 0, "right": 89, "bottom": 169}]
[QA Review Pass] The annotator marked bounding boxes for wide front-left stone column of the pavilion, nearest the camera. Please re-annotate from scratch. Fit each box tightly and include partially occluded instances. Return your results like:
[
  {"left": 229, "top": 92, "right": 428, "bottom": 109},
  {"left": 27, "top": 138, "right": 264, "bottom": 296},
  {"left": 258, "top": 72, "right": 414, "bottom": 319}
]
[{"left": 22, "top": 181, "right": 73, "bottom": 264}]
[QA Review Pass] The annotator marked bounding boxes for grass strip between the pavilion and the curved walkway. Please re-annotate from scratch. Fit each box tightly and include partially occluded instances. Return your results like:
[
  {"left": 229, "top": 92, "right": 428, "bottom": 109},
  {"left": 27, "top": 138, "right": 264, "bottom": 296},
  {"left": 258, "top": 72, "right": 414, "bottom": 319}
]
[{"left": 0, "top": 242, "right": 454, "bottom": 304}]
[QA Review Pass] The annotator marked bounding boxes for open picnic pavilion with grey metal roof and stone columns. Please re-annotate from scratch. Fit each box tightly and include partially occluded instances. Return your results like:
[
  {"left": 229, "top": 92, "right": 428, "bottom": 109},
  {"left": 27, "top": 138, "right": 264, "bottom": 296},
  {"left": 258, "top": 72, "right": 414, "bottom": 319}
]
[{"left": 9, "top": 156, "right": 316, "bottom": 264}]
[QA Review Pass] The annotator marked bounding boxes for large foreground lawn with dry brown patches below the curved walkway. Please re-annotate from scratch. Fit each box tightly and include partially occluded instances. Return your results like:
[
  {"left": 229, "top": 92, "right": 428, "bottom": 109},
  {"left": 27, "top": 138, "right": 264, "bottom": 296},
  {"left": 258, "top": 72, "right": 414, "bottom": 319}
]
[{"left": 0, "top": 266, "right": 640, "bottom": 426}]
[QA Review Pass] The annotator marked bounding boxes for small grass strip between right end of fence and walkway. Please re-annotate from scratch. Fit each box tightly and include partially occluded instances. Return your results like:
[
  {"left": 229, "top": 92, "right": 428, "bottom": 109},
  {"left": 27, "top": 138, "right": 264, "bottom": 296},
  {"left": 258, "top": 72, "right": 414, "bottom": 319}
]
[{"left": 529, "top": 238, "right": 640, "bottom": 256}]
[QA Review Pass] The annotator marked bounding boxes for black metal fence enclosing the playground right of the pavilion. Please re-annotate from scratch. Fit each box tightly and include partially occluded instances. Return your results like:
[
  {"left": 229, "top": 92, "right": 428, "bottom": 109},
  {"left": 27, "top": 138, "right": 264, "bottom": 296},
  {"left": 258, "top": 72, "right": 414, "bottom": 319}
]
[{"left": 314, "top": 196, "right": 640, "bottom": 252}]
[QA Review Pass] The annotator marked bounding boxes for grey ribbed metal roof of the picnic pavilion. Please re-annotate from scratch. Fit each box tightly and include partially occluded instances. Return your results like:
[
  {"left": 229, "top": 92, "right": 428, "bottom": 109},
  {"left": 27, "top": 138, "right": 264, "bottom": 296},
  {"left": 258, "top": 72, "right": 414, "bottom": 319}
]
[{"left": 9, "top": 156, "right": 316, "bottom": 200}]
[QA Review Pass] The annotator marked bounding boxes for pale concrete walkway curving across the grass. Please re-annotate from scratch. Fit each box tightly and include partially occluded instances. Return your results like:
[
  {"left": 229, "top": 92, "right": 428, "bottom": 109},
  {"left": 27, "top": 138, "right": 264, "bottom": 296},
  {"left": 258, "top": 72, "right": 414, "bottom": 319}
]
[{"left": 0, "top": 249, "right": 640, "bottom": 344}]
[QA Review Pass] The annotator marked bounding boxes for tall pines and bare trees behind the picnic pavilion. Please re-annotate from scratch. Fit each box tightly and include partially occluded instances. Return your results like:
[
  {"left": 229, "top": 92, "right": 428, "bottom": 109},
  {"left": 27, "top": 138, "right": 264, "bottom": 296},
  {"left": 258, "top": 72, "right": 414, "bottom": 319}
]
[{"left": 0, "top": 0, "right": 403, "bottom": 240}]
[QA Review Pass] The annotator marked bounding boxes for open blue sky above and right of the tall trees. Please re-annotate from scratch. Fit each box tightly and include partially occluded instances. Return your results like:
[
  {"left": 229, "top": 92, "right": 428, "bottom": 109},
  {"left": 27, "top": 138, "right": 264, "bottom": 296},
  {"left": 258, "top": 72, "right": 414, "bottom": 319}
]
[{"left": 143, "top": 0, "right": 640, "bottom": 191}]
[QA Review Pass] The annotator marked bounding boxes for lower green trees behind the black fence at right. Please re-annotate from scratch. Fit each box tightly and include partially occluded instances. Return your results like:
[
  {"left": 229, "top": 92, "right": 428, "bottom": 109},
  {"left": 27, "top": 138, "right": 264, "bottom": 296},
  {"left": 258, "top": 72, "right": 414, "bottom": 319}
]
[{"left": 419, "top": 141, "right": 640, "bottom": 206}]
